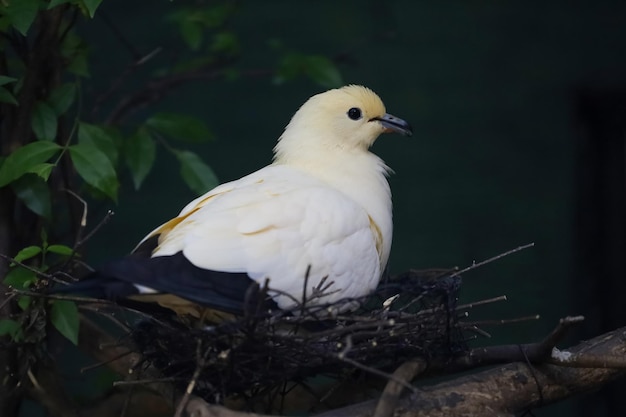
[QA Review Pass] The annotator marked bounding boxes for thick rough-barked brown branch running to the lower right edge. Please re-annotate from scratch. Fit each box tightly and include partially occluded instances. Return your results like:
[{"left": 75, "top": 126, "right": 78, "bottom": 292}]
[{"left": 317, "top": 327, "right": 626, "bottom": 417}]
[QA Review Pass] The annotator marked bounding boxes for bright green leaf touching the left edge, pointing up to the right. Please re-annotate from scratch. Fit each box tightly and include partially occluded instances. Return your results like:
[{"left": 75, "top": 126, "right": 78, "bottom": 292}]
[{"left": 0, "top": 141, "right": 61, "bottom": 187}]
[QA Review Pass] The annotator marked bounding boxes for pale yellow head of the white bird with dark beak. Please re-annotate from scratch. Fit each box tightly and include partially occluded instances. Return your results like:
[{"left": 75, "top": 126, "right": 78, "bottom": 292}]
[{"left": 275, "top": 85, "right": 412, "bottom": 161}]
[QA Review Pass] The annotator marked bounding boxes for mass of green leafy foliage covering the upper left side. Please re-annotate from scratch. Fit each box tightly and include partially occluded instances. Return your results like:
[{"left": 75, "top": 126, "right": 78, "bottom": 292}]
[{"left": 0, "top": 0, "right": 342, "bottom": 410}]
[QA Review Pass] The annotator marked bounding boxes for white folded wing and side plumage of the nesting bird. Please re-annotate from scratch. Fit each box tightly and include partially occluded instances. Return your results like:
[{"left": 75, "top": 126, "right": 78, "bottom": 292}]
[{"left": 140, "top": 165, "right": 383, "bottom": 308}]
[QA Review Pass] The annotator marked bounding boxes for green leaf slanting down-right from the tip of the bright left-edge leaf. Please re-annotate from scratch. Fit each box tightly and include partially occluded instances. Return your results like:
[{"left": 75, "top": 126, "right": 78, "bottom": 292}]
[{"left": 68, "top": 143, "right": 119, "bottom": 202}]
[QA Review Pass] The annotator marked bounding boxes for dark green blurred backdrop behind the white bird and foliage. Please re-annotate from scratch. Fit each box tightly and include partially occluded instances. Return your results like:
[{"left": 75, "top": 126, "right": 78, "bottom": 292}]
[{"left": 73, "top": 0, "right": 626, "bottom": 416}]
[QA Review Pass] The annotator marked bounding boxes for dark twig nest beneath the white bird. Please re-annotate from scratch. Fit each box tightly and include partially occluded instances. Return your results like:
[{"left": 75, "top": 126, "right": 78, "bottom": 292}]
[{"left": 132, "top": 272, "right": 467, "bottom": 403}]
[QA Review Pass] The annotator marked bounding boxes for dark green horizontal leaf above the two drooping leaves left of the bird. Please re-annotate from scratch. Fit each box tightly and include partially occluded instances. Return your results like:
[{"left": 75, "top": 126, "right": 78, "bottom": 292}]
[{"left": 146, "top": 113, "right": 213, "bottom": 143}]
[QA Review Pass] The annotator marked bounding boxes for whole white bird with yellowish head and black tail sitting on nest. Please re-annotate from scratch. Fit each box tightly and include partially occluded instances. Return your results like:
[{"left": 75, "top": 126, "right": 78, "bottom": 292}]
[{"left": 72, "top": 85, "right": 412, "bottom": 316}]
